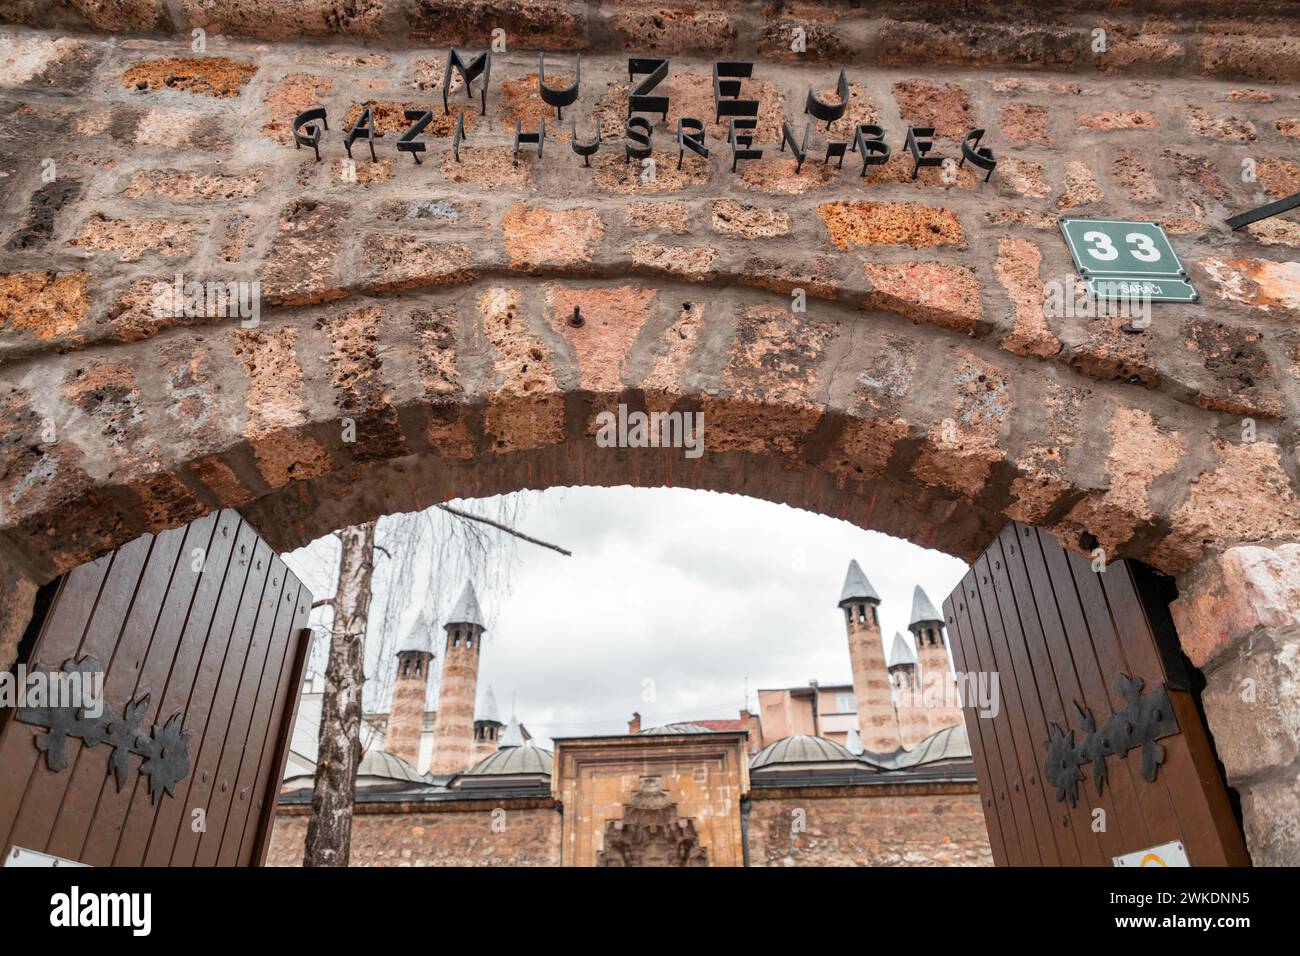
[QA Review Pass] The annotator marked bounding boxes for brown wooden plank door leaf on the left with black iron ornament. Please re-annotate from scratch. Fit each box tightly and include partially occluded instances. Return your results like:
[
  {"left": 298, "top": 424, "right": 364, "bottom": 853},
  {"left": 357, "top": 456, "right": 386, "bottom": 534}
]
[{"left": 0, "top": 510, "right": 312, "bottom": 866}]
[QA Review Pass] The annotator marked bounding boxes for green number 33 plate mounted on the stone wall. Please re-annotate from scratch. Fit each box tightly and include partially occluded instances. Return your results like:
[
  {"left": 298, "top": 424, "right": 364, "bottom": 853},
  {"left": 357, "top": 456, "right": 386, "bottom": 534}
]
[{"left": 1061, "top": 219, "right": 1200, "bottom": 302}]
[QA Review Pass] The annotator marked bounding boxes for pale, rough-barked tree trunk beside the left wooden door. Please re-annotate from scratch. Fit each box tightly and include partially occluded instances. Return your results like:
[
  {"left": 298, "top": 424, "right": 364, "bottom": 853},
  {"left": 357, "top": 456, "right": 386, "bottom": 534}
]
[{"left": 303, "top": 522, "right": 374, "bottom": 866}]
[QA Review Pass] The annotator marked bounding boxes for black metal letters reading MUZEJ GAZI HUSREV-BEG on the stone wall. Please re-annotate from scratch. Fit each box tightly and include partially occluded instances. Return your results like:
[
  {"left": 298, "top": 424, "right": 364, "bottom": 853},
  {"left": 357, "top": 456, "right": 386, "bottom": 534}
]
[{"left": 293, "top": 48, "right": 997, "bottom": 182}]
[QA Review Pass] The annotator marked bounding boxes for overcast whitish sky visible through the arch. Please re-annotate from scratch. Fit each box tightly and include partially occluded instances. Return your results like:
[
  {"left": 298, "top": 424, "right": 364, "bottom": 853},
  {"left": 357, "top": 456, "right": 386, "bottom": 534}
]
[{"left": 287, "top": 488, "right": 966, "bottom": 739}]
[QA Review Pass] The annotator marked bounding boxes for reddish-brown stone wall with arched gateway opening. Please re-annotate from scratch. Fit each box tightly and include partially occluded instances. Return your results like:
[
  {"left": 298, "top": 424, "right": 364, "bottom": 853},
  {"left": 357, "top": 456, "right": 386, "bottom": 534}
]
[{"left": 0, "top": 1, "right": 1300, "bottom": 860}]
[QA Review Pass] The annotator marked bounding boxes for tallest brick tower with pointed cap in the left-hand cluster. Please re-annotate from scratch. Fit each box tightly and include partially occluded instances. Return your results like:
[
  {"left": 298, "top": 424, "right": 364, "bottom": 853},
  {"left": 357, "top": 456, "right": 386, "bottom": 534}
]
[{"left": 429, "top": 583, "right": 485, "bottom": 775}]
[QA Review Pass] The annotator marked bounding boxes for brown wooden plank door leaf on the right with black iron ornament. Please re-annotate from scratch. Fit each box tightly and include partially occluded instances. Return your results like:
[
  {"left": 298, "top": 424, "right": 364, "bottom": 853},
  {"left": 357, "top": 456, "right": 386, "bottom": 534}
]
[{"left": 944, "top": 522, "right": 1249, "bottom": 866}]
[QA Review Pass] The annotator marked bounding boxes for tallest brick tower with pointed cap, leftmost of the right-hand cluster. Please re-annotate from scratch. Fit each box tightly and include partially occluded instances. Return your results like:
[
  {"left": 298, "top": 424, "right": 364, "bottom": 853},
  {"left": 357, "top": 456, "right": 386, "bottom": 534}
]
[{"left": 840, "top": 561, "right": 900, "bottom": 753}]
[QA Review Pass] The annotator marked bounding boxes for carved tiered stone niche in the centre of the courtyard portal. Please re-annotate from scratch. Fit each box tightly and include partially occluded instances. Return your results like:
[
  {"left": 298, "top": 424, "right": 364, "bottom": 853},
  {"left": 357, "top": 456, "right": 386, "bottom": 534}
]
[{"left": 595, "top": 777, "right": 709, "bottom": 866}]
